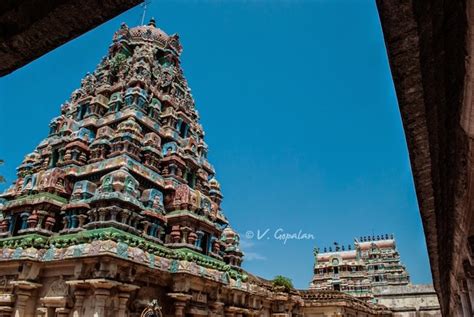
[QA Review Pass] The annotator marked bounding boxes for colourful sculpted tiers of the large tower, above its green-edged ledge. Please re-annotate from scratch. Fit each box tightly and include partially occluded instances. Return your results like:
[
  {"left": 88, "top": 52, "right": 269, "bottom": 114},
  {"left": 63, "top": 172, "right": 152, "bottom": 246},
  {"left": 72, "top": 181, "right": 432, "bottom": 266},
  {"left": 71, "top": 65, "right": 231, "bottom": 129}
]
[{"left": 0, "top": 20, "right": 243, "bottom": 269}]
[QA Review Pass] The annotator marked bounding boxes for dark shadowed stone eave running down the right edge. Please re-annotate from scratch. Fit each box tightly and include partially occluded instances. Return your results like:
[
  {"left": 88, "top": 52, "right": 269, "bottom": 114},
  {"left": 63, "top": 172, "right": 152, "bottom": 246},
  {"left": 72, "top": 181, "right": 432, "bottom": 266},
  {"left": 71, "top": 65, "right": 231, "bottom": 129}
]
[{"left": 377, "top": 0, "right": 472, "bottom": 316}]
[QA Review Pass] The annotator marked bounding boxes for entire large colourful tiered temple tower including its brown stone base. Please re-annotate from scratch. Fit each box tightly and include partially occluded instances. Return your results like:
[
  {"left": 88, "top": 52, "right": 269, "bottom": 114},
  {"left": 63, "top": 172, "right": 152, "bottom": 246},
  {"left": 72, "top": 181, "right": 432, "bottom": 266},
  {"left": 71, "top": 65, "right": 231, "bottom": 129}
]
[{"left": 0, "top": 20, "right": 299, "bottom": 316}]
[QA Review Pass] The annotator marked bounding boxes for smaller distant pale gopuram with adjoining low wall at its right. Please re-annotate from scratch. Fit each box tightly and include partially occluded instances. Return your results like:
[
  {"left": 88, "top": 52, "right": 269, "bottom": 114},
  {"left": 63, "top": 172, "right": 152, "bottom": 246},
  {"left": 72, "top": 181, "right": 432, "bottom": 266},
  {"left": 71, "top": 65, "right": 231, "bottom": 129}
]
[{"left": 310, "top": 234, "right": 441, "bottom": 317}]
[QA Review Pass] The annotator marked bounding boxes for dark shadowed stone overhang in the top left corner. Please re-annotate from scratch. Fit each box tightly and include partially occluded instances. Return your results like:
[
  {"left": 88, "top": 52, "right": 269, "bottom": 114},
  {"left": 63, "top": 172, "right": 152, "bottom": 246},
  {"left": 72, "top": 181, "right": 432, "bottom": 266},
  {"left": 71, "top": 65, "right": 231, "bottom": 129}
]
[{"left": 0, "top": 0, "right": 142, "bottom": 76}]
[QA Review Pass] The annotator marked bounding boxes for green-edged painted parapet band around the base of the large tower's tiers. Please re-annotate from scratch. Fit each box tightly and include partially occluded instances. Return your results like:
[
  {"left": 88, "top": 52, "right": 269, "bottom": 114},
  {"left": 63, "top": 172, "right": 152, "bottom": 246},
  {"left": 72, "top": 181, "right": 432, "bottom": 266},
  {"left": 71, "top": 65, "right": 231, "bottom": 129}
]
[{"left": 0, "top": 228, "right": 247, "bottom": 282}]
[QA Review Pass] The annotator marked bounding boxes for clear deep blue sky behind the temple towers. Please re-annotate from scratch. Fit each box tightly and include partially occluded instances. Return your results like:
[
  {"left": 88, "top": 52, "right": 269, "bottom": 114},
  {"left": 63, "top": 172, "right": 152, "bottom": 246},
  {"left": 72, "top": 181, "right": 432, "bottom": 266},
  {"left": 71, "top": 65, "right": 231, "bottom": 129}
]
[{"left": 0, "top": 0, "right": 431, "bottom": 288}]
